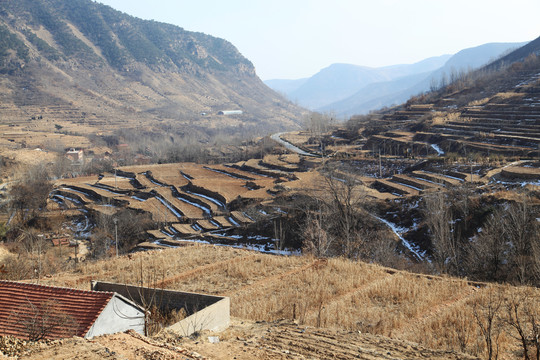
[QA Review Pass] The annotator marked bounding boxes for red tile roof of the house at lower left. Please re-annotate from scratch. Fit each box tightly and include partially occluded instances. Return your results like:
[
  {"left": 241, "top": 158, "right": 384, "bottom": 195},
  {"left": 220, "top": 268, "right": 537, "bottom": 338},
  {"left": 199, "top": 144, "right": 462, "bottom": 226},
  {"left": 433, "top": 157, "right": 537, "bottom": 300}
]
[{"left": 0, "top": 281, "right": 114, "bottom": 339}]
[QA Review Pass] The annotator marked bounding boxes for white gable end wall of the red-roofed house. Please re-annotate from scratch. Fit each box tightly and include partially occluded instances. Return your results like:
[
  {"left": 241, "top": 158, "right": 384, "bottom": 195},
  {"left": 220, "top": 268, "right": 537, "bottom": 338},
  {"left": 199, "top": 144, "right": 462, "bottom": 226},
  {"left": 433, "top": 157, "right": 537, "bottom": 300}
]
[{"left": 85, "top": 294, "right": 145, "bottom": 339}]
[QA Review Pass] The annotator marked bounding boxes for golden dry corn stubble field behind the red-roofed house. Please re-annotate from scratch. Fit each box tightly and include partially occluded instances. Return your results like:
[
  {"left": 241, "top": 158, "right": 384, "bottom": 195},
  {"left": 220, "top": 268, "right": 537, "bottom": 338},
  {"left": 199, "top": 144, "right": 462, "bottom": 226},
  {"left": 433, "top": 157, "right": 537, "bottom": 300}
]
[{"left": 39, "top": 245, "right": 540, "bottom": 358}]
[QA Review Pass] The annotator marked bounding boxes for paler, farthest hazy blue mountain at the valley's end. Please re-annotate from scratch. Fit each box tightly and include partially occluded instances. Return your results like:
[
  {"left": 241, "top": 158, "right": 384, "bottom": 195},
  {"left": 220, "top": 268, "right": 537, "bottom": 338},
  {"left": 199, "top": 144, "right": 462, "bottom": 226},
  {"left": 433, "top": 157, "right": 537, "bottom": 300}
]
[{"left": 265, "top": 55, "right": 450, "bottom": 109}]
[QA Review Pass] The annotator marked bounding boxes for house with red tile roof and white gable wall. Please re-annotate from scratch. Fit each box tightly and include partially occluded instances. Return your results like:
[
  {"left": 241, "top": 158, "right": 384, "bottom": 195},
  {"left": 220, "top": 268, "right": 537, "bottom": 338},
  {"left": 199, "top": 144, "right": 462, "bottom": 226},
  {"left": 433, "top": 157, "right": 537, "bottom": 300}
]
[{"left": 0, "top": 281, "right": 145, "bottom": 340}]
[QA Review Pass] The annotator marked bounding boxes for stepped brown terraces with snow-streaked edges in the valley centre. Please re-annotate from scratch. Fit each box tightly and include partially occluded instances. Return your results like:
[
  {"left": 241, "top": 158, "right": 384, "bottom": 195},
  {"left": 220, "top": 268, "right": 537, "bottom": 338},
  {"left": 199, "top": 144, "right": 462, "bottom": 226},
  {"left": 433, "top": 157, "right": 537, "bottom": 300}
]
[{"left": 49, "top": 155, "right": 308, "bottom": 247}]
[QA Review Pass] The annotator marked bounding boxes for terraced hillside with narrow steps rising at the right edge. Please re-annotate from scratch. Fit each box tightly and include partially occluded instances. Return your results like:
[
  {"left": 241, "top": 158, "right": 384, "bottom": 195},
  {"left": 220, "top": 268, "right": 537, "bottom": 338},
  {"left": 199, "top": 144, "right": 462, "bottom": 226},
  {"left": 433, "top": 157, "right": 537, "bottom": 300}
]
[{"left": 368, "top": 72, "right": 540, "bottom": 157}]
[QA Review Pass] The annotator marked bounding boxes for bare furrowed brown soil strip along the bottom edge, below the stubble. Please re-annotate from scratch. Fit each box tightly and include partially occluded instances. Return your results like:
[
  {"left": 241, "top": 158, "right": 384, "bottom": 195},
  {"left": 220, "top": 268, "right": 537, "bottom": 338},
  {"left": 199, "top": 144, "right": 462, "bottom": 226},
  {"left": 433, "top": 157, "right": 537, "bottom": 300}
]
[{"left": 17, "top": 319, "right": 475, "bottom": 360}]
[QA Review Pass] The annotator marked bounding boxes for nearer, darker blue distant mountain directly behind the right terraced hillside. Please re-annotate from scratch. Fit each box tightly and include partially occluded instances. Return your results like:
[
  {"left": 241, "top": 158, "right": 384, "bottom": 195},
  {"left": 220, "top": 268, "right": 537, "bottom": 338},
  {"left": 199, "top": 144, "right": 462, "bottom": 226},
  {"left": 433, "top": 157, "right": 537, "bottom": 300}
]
[{"left": 317, "top": 43, "right": 526, "bottom": 117}]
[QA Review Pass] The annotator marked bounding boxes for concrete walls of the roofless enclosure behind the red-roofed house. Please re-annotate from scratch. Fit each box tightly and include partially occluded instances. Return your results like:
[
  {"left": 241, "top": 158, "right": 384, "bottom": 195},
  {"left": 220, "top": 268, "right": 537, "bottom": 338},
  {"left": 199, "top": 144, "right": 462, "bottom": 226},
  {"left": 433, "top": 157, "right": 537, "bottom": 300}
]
[{"left": 92, "top": 281, "right": 231, "bottom": 336}]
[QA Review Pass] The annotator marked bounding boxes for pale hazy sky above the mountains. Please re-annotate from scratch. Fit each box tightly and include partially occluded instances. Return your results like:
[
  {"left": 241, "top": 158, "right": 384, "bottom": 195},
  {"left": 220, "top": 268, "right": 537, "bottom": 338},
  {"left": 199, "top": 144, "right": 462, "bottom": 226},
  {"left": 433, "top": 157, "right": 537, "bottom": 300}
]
[{"left": 98, "top": 0, "right": 540, "bottom": 80}]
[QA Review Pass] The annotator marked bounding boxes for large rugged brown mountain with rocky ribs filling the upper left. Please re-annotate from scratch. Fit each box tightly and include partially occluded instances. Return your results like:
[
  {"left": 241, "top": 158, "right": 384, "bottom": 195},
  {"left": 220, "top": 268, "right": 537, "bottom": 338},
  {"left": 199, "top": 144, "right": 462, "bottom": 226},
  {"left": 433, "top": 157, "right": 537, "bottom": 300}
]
[{"left": 0, "top": 0, "right": 303, "bottom": 139}]
